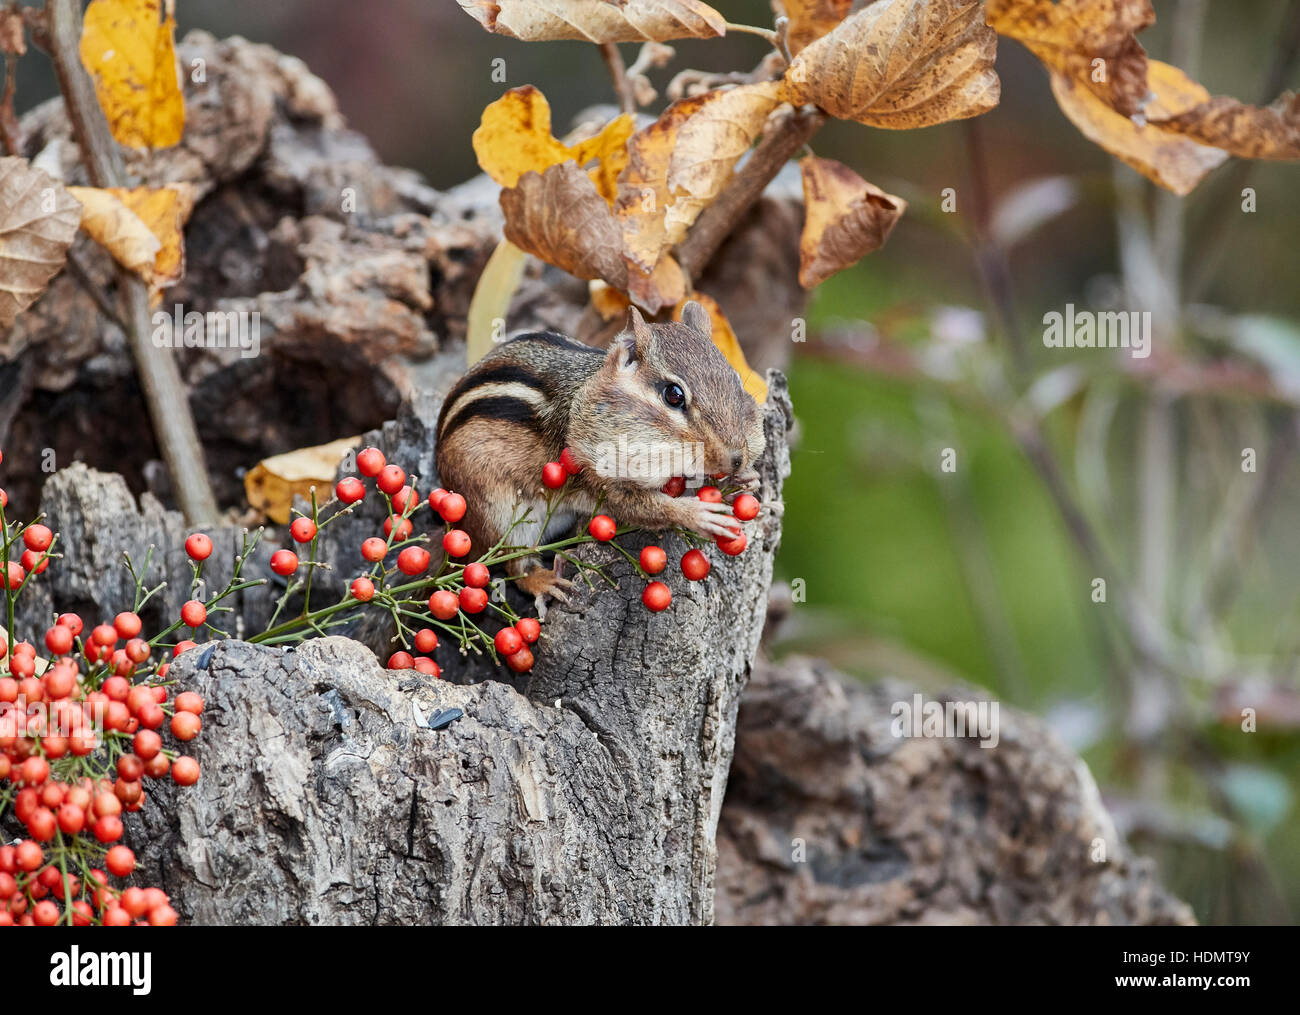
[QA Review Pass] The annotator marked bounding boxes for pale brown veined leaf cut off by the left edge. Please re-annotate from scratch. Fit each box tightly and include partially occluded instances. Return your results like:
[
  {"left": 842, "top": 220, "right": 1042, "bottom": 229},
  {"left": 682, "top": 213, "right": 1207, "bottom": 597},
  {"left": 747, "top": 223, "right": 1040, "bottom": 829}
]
[{"left": 0, "top": 159, "right": 81, "bottom": 328}]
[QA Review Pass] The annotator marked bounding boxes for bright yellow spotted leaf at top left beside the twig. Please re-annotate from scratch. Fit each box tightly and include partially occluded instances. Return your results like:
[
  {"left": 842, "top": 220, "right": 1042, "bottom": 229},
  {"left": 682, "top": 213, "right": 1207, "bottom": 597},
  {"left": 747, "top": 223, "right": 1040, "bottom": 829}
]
[{"left": 81, "top": 0, "right": 185, "bottom": 148}]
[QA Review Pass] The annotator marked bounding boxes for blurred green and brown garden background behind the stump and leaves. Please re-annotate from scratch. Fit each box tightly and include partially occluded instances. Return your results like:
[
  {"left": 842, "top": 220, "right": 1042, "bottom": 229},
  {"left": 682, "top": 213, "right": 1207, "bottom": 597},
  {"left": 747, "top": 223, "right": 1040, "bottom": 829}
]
[{"left": 18, "top": 0, "right": 1300, "bottom": 923}]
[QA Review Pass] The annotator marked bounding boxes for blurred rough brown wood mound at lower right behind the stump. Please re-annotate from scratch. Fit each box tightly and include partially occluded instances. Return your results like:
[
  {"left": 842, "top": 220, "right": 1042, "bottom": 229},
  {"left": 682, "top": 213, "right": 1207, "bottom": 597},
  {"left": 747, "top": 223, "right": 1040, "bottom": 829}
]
[{"left": 718, "top": 658, "right": 1193, "bottom": 924}]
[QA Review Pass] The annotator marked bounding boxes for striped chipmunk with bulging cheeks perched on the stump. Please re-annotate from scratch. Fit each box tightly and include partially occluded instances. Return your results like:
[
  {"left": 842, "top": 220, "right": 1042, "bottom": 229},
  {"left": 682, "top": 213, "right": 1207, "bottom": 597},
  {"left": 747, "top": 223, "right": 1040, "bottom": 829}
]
[{"left": 437, "top": 302, "right": 764, "bottom": 604}]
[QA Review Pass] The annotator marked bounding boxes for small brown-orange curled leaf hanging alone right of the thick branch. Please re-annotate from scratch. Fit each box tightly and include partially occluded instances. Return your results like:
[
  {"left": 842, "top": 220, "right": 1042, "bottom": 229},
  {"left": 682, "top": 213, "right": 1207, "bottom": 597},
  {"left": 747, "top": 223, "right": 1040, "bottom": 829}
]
[{"left": 800, "top": 156, "right": 907, "bottom": 289}]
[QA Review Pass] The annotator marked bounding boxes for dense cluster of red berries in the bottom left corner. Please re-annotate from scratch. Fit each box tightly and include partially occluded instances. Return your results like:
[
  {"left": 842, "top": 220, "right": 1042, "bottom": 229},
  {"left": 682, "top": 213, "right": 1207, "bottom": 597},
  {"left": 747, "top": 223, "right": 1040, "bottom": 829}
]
[{"left": 0, "top": 447, "right": 202, "bottom": 927}]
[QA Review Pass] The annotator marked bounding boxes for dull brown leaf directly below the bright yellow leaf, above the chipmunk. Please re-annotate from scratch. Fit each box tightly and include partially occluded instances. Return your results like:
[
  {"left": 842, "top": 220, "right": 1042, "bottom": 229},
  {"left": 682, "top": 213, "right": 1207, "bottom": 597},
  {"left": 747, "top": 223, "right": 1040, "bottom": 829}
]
[{"left": 501, "top": 161, "right": 628, "bottom": 289}]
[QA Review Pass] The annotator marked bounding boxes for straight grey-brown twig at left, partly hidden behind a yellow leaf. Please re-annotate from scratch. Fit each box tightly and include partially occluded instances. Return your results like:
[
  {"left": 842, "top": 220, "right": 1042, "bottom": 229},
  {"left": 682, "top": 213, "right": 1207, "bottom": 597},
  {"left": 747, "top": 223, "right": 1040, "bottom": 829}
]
[{"left": 46, "top": 0, "right": 217, "bottom": 525}]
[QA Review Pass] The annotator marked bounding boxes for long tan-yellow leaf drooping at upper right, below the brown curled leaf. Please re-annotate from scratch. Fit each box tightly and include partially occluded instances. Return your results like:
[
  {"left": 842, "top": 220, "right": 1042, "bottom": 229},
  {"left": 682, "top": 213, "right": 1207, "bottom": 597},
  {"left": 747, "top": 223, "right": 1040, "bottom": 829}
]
[{"left": 1052, "top": 69, "right": 1227, "bottom": 195}]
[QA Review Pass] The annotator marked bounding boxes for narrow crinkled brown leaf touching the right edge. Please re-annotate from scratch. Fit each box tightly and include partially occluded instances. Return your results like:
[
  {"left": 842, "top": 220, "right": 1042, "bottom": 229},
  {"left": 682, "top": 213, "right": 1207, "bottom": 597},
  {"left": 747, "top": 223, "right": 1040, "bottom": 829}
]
[{"left": 1147, "top": 92, "right": 1300, "bottom": 160}]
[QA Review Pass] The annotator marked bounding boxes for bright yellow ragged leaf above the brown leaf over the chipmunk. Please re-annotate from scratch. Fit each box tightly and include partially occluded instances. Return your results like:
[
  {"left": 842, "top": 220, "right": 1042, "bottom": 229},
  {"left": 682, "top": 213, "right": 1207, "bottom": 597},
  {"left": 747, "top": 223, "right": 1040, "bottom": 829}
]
[{"left": 471, "top": 84, "right": 633, "bottom": 204}]
